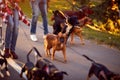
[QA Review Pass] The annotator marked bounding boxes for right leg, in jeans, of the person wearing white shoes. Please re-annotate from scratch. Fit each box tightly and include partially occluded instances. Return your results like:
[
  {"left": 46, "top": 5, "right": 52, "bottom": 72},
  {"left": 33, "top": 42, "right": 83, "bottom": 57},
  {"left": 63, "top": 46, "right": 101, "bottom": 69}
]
[{"left": 39, "top": 0, "right": 48, "bottom": 35}]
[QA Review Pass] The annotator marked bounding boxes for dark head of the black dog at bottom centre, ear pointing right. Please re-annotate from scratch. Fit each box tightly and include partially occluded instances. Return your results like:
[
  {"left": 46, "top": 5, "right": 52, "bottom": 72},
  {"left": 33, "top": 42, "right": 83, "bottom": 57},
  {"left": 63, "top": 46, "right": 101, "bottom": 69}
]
[{"left": 50, "top": 71, "right": 68, "bottom": 80}]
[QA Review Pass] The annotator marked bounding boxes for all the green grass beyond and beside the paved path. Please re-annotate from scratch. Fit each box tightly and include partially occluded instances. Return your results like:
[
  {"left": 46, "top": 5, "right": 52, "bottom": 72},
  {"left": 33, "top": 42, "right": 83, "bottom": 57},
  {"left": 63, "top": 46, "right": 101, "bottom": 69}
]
[{"left": 20, "top": 0, "right": 120, "bottom": 50}]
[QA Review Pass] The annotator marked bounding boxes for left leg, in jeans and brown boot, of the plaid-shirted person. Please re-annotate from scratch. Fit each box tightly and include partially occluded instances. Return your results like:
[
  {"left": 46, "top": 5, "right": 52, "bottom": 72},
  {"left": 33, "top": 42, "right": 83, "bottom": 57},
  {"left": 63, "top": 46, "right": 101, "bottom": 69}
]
[{"left": 4, "top": 15, "right": 14, "bottom": 58}]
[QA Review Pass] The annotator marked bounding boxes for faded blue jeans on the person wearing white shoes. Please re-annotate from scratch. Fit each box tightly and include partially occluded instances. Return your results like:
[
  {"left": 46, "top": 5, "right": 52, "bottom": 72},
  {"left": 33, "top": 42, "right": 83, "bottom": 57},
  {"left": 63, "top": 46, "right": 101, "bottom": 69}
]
[{"left": 30, "top": 0, "right": 48, "bottom": 34}]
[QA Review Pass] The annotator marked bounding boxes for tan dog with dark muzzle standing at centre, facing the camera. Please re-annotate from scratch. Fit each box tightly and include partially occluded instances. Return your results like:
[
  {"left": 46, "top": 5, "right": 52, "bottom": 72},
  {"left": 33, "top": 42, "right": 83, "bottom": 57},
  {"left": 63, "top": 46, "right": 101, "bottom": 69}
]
[{"left": 44, "top": 32, "right": 67, "bottom": 62}]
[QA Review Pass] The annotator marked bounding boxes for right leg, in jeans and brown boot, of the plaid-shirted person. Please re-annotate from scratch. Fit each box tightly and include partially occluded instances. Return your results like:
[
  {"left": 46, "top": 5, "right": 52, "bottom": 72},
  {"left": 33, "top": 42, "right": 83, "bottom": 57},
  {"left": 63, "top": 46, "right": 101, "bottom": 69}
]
[{"left": 10, "top": 9, "right": 19, "bottom": 59}]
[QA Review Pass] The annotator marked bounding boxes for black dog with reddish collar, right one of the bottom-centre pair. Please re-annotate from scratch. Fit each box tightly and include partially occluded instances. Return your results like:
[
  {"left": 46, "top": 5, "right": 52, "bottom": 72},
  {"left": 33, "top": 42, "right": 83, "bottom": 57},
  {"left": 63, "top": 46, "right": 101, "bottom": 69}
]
[{"left": 36, "top": 47, "right": 68, "bottom": 80}]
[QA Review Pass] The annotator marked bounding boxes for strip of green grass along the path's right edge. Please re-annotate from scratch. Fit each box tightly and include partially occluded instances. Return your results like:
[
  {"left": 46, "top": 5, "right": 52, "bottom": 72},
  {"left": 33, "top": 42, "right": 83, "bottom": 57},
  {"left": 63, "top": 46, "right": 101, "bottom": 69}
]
[{"left": 83, "top": 28, "right": 120, "bottom": 50}]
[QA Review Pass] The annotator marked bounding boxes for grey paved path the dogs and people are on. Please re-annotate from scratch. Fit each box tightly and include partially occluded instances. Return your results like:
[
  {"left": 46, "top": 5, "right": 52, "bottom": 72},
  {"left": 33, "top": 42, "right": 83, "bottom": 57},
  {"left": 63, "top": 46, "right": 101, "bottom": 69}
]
[{"left": 0, "top": 21, "right": 120, "bottom": 80}]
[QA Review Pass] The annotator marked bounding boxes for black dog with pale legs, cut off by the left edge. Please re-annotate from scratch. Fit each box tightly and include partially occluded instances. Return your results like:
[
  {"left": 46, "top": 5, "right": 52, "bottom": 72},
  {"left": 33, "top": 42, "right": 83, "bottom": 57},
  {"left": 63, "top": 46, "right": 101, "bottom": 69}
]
[{"left": 0, "top": 53, "right": 10, "bottom": 78}]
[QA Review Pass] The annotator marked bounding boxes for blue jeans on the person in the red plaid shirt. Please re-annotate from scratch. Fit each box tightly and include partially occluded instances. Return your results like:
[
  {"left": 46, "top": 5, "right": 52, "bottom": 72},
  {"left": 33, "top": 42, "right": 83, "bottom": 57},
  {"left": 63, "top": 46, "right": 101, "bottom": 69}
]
[{"left": 5, "top": 9, "right": 19, "bottom": 51}]
